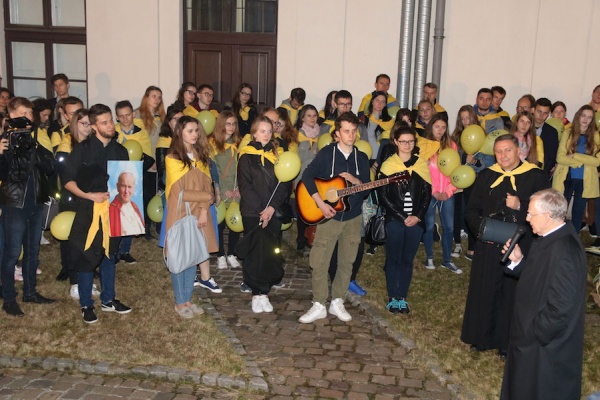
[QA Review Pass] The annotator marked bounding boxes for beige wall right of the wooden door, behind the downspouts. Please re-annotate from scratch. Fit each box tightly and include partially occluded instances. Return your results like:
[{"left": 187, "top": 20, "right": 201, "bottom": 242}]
[{"left": 277, "top": 0, "right": 600, "bottom": 122}]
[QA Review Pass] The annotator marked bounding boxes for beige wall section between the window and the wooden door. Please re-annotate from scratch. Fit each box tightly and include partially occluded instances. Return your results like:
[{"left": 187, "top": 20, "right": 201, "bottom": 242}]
[{"left": 86, "top": 0, "right": 183, "bottom": 108}]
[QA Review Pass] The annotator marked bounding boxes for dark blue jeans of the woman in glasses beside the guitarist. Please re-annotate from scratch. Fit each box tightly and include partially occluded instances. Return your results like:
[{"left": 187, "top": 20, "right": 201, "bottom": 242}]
[{"left": 385, "top": 221, "right": 423, "bottom": 299}]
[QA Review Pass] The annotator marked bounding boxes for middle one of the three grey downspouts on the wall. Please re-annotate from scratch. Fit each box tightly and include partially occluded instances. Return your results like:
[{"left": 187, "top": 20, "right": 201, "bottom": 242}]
[{"left": 413, "top": 0, "right": 432, "bottom": 108}]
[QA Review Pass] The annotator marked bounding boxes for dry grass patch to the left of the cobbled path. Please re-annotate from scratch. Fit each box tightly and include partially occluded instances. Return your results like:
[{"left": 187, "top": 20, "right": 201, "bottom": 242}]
[{"left": 0, "top": 233, "right": 244, "bottom": 375}]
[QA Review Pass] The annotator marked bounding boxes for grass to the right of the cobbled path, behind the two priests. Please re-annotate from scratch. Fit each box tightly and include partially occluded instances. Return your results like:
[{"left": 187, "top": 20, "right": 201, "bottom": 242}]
[{"left": 358, "top": 234, "right": 600, "bottom": 399}]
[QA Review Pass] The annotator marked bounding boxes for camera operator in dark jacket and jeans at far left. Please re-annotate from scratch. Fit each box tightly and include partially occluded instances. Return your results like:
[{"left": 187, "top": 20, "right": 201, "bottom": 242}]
[{"left": 0, "top": 97, "right": 56, "bottom": 317}]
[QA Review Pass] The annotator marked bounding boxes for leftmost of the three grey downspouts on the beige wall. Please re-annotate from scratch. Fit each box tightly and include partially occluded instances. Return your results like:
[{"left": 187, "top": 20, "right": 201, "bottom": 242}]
[{"left": 396, "top": 0, "right": 416, "bottom": 108}]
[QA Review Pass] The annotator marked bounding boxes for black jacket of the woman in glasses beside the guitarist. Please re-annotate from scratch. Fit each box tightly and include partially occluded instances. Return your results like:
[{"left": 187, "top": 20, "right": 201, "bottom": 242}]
[{"left": 377, "top": 156, "right": 431, "bottom": 228}]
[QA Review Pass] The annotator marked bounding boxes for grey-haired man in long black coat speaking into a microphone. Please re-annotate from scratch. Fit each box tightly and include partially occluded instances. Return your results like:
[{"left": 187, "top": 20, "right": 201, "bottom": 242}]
[{"left": 501, "top": 189, "right": 587, "bottom": 400}]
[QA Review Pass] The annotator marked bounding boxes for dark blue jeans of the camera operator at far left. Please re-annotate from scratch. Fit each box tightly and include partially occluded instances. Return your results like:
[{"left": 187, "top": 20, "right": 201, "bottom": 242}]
[{"left": 1, "top": 204, "right": 43, "bottom": 303}]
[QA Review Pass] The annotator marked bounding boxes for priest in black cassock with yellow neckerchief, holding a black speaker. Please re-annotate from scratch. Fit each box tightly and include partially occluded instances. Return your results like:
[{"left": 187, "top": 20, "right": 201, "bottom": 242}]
[{"left": 461, "top": 135, "right": 549, "bottom": 356}]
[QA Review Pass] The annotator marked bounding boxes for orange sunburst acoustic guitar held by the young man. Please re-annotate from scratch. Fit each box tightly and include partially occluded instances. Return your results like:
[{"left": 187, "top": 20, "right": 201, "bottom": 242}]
[{"left": 296, "top": 171, "right": 410, "bottom": 225}]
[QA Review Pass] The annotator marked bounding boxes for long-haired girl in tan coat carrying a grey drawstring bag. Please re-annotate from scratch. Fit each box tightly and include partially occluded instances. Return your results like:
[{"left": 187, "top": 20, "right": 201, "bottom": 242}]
[{"left": 165, "top": 116, "right": 222, "bottom": 318}]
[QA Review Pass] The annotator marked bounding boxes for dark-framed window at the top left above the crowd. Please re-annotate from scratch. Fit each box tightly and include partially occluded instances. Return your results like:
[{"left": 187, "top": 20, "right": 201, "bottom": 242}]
[{"left": 4, "top": 0, "right": 87, "bottom": 105}]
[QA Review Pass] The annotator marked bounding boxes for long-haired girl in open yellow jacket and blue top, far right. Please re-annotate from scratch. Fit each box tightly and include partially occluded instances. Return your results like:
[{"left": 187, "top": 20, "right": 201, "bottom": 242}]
[{"left": 552, "top": 104, "right": 600, "bottom": 232}]
